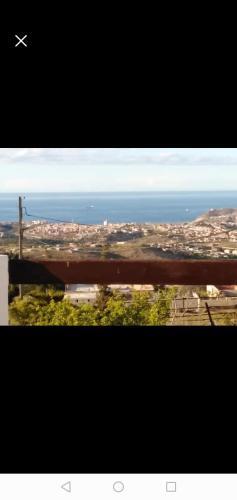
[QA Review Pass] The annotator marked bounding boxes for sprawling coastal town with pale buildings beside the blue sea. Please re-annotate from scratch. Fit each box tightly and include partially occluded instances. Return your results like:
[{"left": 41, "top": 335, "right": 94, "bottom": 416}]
[{"left": 0, "top": 209, "right": 237, "bottom": 259}]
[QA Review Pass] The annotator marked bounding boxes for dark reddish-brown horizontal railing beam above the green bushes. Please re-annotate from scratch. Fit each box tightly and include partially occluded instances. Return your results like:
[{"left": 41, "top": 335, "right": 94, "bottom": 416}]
[{"left": 9, "top": 259, "right": 237, "bottom": 285}]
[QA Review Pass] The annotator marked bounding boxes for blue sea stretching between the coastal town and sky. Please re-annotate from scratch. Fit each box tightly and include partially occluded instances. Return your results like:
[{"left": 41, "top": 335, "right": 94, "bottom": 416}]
[{"left": 0, "top": 191, "right": 237, "bottom": 224}]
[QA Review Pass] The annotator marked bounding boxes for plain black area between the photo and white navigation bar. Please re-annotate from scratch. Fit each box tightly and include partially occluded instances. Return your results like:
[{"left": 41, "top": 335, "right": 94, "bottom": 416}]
[{"left": 0, "top": 327, "right": 236, "bottom": 473}]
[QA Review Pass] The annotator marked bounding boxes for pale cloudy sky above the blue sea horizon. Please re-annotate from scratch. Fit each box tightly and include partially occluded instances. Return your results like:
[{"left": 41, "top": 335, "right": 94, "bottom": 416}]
[{"left": 0, "top": 148, "right": 237, "bottom": 193}]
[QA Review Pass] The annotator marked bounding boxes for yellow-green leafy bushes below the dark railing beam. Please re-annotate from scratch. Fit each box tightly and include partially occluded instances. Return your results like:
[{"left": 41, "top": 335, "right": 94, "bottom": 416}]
[{"left": 9, "top": 289, "right": 175, "bottom": 326}]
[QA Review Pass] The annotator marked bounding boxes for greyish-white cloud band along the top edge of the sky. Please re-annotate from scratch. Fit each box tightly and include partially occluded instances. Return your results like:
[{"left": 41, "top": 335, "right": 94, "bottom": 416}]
[{"left": 0, "top": 148, "right": 237, "bottom": 166}]
